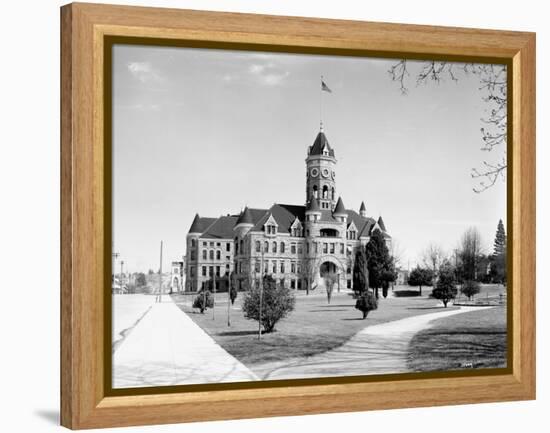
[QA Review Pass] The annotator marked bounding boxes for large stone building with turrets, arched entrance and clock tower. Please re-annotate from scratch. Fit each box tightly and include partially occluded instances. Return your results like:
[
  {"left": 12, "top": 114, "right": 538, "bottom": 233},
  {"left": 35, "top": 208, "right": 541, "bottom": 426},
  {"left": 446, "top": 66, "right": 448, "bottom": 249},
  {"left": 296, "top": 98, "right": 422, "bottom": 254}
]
[{"left": 185, "top": 128, "right": 391, "bottom": 291}]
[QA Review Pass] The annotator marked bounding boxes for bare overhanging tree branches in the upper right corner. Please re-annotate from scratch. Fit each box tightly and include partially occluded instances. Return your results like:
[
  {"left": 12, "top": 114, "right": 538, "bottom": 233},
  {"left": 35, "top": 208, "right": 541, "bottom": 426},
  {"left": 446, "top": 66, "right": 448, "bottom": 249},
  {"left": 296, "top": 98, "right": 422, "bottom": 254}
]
[{"left": 388, "top": 59, "right": 508, "bottom": 193}]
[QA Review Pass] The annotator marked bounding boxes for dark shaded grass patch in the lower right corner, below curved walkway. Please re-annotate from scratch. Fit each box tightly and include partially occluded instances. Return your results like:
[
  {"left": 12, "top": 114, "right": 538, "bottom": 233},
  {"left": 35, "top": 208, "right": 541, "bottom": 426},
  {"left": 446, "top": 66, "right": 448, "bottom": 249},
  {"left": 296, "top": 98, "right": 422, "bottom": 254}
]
[{"left": 408, "top": 307, "right": 507, "bottom": 371}]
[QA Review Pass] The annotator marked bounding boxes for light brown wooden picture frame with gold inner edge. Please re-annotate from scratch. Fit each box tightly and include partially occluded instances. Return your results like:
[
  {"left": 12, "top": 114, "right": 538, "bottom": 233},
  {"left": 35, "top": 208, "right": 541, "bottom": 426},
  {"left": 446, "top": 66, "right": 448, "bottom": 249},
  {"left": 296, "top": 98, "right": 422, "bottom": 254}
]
[{"left": 61, "top": 3, "right": 535, "bottom": 429}]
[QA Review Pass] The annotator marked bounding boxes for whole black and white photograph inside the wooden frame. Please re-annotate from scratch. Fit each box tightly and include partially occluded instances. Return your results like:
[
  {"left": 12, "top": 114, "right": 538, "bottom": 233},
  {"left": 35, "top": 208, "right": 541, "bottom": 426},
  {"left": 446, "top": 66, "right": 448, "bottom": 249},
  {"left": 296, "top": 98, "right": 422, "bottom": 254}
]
[{"left": 107, "top": 44, "right": 509, "bottom": 389}]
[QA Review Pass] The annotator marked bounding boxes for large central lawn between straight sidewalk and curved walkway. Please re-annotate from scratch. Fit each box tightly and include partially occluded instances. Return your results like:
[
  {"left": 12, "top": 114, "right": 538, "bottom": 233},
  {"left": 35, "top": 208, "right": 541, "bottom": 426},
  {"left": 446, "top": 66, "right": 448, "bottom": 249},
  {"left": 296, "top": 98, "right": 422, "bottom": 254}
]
[{"left": 172, "top": 290, "right": 460, "bottom": 367}]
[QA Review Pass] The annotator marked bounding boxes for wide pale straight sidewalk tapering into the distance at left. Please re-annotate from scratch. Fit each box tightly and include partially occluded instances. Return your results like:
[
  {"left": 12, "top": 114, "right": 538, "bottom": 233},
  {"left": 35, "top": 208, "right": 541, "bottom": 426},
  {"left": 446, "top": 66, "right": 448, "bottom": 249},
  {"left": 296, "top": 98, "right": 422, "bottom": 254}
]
[{"left": 113, "top": 295, "right": 258, "bottom": 388}]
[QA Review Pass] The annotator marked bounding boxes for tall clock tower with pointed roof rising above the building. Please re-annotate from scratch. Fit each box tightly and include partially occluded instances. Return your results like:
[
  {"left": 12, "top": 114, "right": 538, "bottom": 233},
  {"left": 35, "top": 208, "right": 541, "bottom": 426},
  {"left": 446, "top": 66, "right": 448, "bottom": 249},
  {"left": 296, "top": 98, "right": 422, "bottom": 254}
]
[{"left": 306, "top": 124, "right": 337, "bottom": 210}]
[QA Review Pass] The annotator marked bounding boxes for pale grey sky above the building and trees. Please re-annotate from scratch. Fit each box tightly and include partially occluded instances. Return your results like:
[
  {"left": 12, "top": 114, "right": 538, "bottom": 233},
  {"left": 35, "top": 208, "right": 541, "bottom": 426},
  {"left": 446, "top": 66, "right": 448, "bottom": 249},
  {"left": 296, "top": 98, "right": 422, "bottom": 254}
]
[{"left": 113, "top": 45, "right": 506, "bottom": 271}]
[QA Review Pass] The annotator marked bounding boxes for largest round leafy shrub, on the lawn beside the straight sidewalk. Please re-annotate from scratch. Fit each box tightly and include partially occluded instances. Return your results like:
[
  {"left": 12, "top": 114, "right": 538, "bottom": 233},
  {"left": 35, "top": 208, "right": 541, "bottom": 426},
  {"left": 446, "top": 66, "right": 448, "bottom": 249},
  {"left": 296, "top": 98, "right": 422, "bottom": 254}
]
[{"left": 243, "top": 276, "right": 296, "bottom": 333}]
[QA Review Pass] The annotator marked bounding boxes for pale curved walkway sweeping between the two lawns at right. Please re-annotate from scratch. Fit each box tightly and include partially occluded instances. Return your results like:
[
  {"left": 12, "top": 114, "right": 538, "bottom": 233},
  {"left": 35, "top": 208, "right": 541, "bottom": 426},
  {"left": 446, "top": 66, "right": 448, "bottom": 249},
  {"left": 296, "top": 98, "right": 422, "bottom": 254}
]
[{"left": 253, "top": 307, "right": 491, "bottom": 380}]
